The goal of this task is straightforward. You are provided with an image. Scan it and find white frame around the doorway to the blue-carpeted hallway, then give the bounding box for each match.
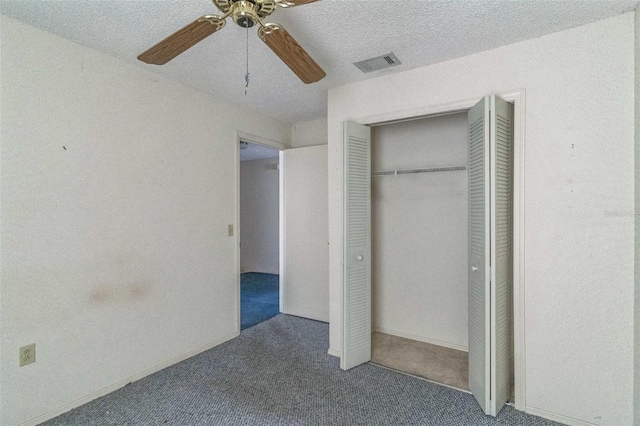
[234,130,291,335]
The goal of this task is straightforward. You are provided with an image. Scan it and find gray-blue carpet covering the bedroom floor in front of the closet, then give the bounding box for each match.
[45,315,555,426]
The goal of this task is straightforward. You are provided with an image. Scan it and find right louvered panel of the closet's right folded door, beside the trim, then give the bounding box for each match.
[489,96,513,416]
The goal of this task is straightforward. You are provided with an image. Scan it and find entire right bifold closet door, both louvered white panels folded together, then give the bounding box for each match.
[469,96,513,416]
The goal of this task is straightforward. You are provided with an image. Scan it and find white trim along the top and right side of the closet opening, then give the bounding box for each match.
[341,89,526,411]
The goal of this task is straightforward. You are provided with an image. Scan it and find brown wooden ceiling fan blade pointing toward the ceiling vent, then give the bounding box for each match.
[258,24,327,84]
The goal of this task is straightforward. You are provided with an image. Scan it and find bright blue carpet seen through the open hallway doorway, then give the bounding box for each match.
[240,272,280,330]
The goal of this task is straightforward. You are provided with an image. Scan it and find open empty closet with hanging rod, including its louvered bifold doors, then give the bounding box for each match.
[341,96,513,416]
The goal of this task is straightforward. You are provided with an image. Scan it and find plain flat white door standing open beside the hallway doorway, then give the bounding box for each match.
[282,144,329,322]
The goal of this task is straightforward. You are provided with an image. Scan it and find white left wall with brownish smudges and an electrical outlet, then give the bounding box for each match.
[0,16,291,426]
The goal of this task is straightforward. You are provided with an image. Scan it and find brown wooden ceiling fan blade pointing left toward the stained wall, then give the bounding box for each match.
[138,15,226,65]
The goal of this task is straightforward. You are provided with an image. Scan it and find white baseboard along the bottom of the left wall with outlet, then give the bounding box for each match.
[20,332,240,426]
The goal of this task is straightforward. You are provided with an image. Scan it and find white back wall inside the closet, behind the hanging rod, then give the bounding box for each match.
[371,113,469,351]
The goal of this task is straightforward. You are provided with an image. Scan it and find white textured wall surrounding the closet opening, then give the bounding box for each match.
[328,13,634,425]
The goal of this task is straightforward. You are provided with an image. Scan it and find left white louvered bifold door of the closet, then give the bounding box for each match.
[340,122,371,370]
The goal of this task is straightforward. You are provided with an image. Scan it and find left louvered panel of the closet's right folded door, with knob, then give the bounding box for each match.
[468,98,491,414]
